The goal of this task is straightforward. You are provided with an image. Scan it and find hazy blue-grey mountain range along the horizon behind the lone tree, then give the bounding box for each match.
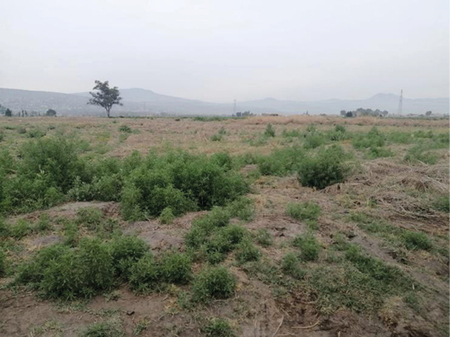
[0,88,449,116]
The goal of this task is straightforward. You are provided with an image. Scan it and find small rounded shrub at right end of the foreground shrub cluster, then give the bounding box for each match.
[192,267,236,302]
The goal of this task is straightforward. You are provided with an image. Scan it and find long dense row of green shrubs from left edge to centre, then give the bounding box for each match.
[0,137,248,219]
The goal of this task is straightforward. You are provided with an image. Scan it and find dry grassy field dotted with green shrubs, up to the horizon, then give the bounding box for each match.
[0,116,449,337]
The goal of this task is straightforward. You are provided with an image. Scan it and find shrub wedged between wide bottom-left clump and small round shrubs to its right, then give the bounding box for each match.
[110,235,149,278]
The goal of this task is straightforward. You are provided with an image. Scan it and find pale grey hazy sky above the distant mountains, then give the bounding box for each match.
[0,0,450,102]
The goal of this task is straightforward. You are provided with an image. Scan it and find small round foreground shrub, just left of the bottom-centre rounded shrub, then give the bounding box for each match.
[160,252,192,284]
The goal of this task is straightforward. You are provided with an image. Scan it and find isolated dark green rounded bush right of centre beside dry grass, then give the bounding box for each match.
[298,146,348,189]
